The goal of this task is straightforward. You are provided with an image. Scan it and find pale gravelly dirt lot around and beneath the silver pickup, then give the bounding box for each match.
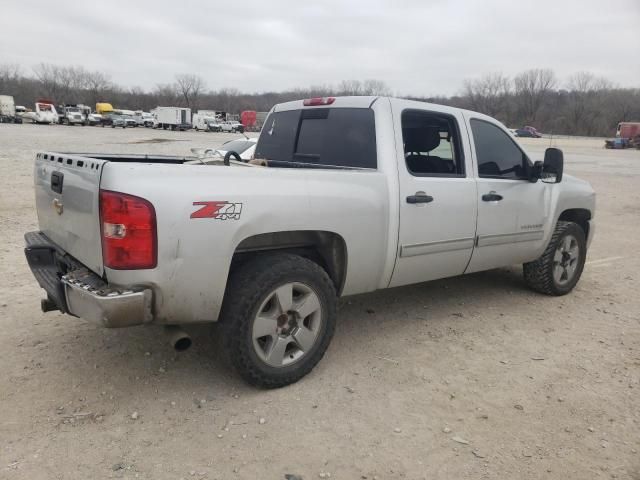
[0,125,640,480]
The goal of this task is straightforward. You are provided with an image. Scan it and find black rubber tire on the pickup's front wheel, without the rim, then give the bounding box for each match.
[522,221,587,296]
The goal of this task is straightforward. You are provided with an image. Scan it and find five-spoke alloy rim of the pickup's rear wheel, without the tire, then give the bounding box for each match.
[252,282,323,368]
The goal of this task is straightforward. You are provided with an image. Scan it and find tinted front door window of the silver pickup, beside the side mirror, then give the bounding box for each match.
[470,118,529,180]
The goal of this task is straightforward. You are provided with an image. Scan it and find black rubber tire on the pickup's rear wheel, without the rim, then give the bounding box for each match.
[220,254,337,388]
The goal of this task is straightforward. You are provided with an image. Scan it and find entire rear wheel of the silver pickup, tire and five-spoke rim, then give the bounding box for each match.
[221,254,337,388]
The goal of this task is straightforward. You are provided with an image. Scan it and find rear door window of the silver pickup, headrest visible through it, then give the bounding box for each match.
[402,110,464,177]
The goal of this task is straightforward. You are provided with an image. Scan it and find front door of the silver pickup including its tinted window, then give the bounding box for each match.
[466,116,551,272]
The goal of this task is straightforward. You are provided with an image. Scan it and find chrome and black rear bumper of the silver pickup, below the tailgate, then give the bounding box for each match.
[25,232,153,328]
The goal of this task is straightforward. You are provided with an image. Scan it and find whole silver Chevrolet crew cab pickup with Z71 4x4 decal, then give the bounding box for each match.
[25,97,595,387]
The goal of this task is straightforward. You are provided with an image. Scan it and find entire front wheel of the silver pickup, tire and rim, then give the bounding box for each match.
[522,221,587,296]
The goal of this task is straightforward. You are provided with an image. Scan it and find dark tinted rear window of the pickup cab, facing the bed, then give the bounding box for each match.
[255,108,377,169]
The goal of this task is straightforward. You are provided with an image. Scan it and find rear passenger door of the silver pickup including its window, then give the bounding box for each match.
[390,102,477,286]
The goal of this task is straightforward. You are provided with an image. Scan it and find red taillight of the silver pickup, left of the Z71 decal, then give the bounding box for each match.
[100,190,158,270]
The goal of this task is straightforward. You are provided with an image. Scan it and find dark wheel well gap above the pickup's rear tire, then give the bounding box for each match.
[231,230,347,295]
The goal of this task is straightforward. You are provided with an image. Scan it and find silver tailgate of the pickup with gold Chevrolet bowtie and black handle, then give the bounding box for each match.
[34,152,107,275]
